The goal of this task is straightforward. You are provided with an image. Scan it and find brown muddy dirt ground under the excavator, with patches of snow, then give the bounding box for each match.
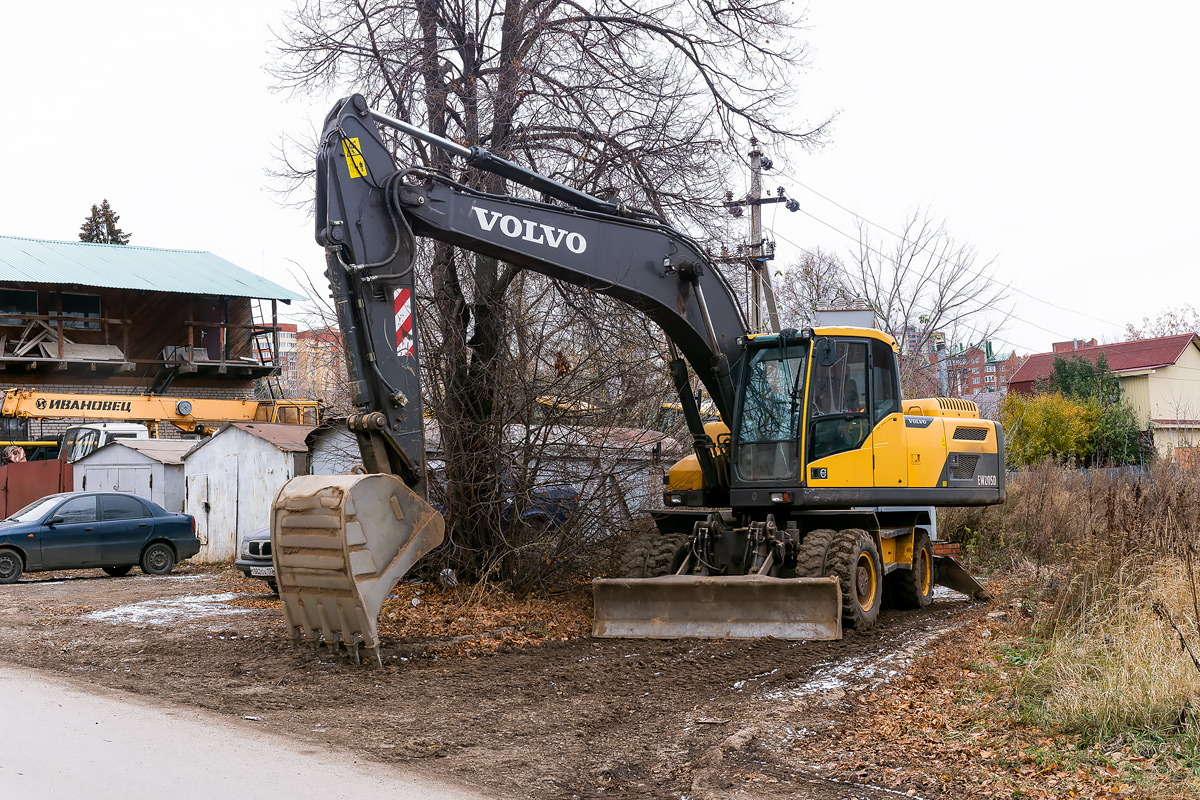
[0,565,996,800]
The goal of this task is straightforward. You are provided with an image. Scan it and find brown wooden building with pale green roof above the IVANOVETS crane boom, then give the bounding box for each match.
[0,236,305,438]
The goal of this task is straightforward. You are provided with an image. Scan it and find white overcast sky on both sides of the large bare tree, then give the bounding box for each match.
[0,0,1200,353]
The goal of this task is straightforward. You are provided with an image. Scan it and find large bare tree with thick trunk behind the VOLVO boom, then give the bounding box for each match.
[274,0,824,587]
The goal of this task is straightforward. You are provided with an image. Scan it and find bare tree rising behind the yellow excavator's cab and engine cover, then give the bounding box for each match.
[846,210,1012,392]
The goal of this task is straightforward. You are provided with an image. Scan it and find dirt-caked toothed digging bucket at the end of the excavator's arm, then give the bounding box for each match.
[271,475,445,657]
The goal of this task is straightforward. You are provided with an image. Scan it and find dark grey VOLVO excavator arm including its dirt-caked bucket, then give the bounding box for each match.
[271,95,746,657]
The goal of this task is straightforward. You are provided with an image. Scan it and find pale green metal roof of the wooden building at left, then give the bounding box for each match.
[0,236,307,301]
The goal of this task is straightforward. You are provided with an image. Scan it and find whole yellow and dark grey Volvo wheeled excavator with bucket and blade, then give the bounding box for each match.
[271,95,1004,660]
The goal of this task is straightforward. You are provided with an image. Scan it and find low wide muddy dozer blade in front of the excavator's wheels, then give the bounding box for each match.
[592,575,841,639]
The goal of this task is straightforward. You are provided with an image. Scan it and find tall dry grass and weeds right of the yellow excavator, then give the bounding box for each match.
[938,463,1200,792]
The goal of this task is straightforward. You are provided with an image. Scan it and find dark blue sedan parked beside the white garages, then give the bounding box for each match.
[0,492,200,583]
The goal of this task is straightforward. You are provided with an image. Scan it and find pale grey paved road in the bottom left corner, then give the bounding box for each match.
[0,667,484,800]
